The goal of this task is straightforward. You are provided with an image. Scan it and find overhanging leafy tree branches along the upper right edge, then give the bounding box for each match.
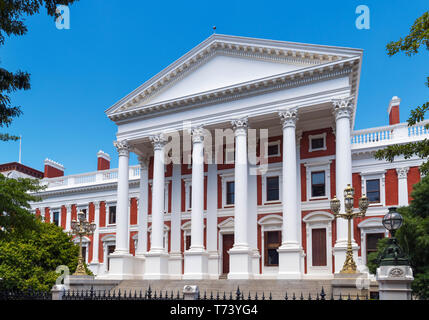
[375,12,429,174]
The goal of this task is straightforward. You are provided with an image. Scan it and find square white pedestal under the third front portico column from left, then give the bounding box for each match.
[182,249,209,280]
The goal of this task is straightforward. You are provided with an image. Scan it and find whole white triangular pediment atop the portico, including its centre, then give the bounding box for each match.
[106,35,361,118]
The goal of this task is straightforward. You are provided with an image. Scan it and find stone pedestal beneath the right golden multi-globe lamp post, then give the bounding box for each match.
[332,273,370,300]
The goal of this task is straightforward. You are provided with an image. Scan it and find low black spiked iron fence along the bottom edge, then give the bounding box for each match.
[62,287,369,300]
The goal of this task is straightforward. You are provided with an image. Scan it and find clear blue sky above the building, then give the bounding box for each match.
[0,0,429,174]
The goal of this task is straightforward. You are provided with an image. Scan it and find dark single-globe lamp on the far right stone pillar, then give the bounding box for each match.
[379,207,410,266]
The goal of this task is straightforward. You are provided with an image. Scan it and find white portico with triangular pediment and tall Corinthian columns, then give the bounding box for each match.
[106,35,362,280]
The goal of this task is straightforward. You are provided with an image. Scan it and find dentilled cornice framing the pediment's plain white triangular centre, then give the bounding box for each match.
[106,35,362,121]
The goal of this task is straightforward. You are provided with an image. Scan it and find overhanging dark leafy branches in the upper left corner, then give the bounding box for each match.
[0,0,77,141]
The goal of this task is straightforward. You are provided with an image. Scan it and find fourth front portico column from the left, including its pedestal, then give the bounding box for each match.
[228,118,253,279]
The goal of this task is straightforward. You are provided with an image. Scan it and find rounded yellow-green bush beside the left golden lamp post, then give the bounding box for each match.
[0,219,79,291]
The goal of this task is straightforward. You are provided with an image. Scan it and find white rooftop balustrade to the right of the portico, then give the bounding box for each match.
[351,120,429,149]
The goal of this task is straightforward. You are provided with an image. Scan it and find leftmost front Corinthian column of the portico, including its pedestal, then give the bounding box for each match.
[108,140,134,280]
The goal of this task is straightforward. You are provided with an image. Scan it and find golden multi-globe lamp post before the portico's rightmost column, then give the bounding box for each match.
[331,184,368,273]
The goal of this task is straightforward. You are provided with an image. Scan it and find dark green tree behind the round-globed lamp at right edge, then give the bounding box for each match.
[368,176,429,299]
